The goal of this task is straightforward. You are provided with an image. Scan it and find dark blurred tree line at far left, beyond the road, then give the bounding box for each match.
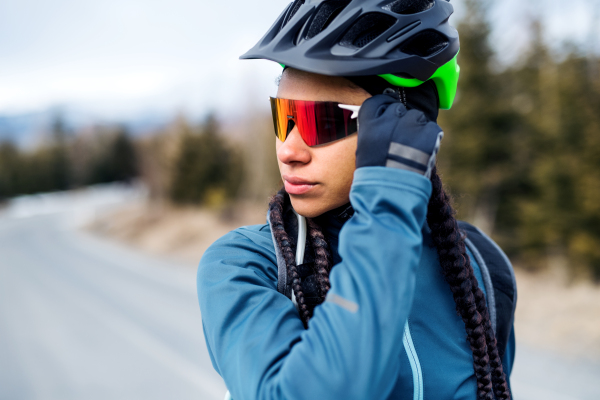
[0,117,138,201]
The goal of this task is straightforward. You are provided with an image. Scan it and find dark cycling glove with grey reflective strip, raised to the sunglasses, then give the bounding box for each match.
[356,94,444,178]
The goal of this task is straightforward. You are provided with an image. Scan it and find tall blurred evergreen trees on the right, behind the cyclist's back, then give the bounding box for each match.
[439,0,600,282]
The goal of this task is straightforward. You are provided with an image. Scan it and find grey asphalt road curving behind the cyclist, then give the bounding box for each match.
[0,186,600,400]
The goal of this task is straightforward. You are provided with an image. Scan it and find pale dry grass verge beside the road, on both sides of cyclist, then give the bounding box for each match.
[89,203,600,360]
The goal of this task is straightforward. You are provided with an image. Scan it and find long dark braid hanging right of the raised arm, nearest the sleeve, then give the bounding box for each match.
[427,168,493,399]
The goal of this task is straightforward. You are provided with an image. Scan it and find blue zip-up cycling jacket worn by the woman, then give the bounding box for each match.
[198,167,515,400]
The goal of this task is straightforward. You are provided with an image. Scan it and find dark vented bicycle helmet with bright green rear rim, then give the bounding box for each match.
[240,0,460,109]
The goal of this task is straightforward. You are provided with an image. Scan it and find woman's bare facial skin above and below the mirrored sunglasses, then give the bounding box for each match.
[275,68,370,218]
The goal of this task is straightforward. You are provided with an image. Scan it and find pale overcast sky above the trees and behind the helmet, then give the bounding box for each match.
[0,0,600,119]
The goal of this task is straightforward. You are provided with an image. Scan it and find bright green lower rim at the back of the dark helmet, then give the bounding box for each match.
[379,53,460,110]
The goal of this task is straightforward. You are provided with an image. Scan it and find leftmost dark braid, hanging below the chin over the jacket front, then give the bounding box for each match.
[269,189,310,327]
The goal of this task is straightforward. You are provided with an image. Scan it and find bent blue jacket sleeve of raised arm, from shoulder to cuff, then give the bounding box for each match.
[198,167,431,400]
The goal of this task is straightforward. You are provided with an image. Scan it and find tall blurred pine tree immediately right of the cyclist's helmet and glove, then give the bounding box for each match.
[440,0,519,234]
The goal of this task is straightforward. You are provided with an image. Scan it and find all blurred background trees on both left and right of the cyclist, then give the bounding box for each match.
[0,0,600,282]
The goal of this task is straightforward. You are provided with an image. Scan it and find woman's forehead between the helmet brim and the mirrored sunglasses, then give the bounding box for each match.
[277,68,370,104]
